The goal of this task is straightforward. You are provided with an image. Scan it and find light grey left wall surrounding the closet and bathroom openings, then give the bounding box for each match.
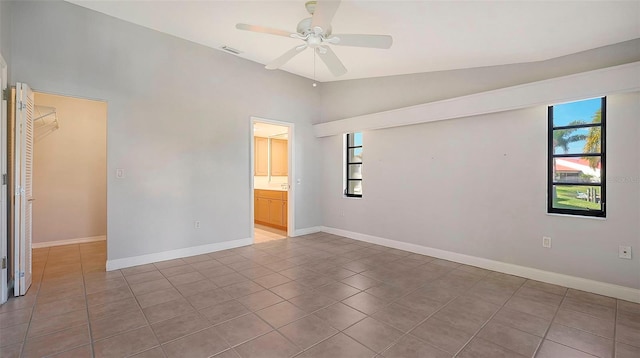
[11,1,322,260]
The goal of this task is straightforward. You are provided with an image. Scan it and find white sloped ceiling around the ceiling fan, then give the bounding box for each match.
[70,0,640,82]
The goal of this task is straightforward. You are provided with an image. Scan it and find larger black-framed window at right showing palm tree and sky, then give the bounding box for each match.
[547,97,607,217]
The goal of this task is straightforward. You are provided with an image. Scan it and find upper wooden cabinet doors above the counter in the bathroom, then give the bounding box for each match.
[253,137,289,176]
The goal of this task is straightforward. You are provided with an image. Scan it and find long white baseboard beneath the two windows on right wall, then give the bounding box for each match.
[322,226,640,303]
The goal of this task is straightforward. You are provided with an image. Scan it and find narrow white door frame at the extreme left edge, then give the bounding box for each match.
[0,54,6,304]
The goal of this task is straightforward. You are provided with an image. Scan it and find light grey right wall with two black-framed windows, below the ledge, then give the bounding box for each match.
[322,93,640,288]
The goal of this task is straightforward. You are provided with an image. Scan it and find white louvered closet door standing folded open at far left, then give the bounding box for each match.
[13,82,34,296]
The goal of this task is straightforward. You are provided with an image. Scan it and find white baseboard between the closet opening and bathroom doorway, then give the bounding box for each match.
[107,238,253,271]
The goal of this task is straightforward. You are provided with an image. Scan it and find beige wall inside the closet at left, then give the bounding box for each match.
[33,93,107,243]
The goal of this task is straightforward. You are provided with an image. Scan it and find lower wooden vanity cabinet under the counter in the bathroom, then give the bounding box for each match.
[254,189,288,230]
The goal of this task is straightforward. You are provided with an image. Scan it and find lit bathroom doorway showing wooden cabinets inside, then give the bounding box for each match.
[251,118,294,243]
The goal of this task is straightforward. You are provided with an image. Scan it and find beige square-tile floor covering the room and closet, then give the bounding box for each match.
[0,233,640,358]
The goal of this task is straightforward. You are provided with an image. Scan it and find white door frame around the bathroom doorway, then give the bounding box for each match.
[249,116,295,242]
